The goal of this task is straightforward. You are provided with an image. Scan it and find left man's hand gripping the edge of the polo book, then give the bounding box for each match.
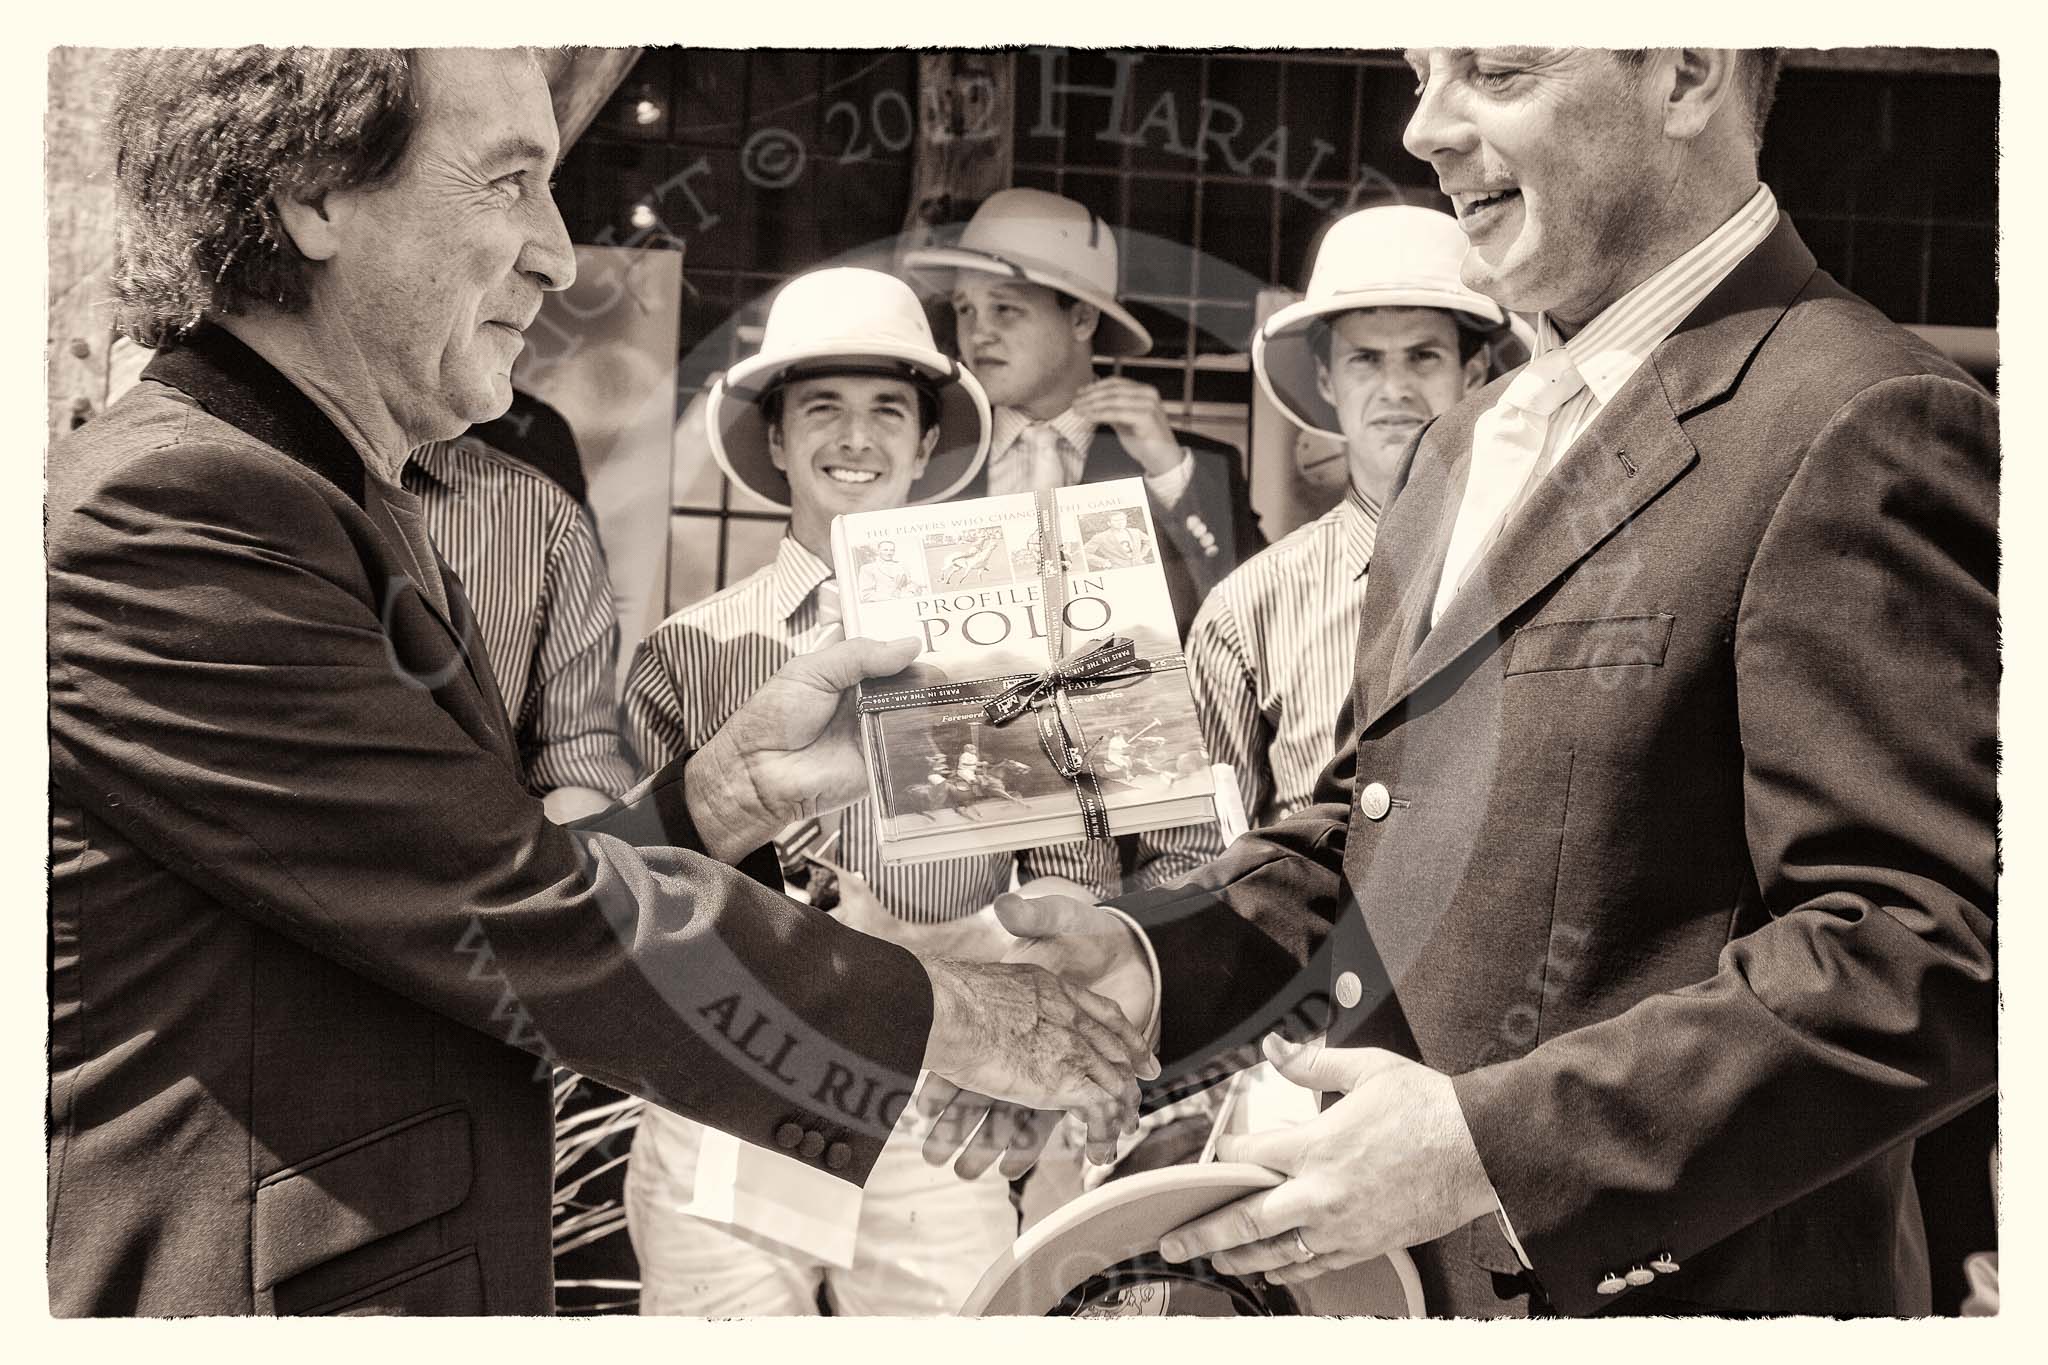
[686,639,918,862]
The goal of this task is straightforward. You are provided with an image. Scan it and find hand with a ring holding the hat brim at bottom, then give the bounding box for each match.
[1159,1036,1497,1285]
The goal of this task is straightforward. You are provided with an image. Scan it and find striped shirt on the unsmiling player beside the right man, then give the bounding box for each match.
[1139,487,1380,880]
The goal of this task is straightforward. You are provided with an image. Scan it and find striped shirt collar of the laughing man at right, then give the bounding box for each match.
[1536,184,1778,405]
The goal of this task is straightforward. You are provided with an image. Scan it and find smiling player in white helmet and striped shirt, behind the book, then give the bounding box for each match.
[625,268,1138,1316]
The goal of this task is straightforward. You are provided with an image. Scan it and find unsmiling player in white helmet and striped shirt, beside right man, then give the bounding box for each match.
[1145,205,1509,888]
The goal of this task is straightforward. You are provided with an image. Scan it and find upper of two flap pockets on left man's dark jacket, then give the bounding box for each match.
[250,1105,471,1293]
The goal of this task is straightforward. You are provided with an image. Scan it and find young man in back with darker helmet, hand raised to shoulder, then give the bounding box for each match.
[903,188,1266,632]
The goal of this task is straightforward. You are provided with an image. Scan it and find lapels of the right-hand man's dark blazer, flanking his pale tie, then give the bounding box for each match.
[1366,215,1815,726]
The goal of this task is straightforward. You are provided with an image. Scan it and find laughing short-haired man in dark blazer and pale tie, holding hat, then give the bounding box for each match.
[971,49,1999,1316]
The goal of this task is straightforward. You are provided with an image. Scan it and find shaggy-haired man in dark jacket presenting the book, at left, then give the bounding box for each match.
[47,49,1153,1316]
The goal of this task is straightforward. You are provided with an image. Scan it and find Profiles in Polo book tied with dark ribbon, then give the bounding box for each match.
[831,479,1214,862]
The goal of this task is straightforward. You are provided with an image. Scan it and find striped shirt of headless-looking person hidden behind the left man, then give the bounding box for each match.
[401,436,633,796]
